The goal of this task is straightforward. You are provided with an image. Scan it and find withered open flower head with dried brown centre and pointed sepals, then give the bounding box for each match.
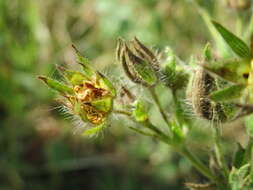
[39,45,116,130]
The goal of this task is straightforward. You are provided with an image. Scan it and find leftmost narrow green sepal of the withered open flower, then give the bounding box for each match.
[38,76,74,94]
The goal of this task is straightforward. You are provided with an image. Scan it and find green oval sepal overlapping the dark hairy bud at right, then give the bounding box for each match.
[209,84,245,102]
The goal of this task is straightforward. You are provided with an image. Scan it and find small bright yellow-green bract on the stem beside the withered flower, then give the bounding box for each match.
[132,100,148,122]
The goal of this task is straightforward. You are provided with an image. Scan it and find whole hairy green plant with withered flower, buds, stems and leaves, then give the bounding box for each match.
[39,21,253,190]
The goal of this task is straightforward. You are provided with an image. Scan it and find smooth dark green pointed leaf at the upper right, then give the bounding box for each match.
[212,21,251,58]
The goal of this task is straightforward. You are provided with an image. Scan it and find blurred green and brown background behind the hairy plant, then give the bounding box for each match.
[0,0,251,190]
